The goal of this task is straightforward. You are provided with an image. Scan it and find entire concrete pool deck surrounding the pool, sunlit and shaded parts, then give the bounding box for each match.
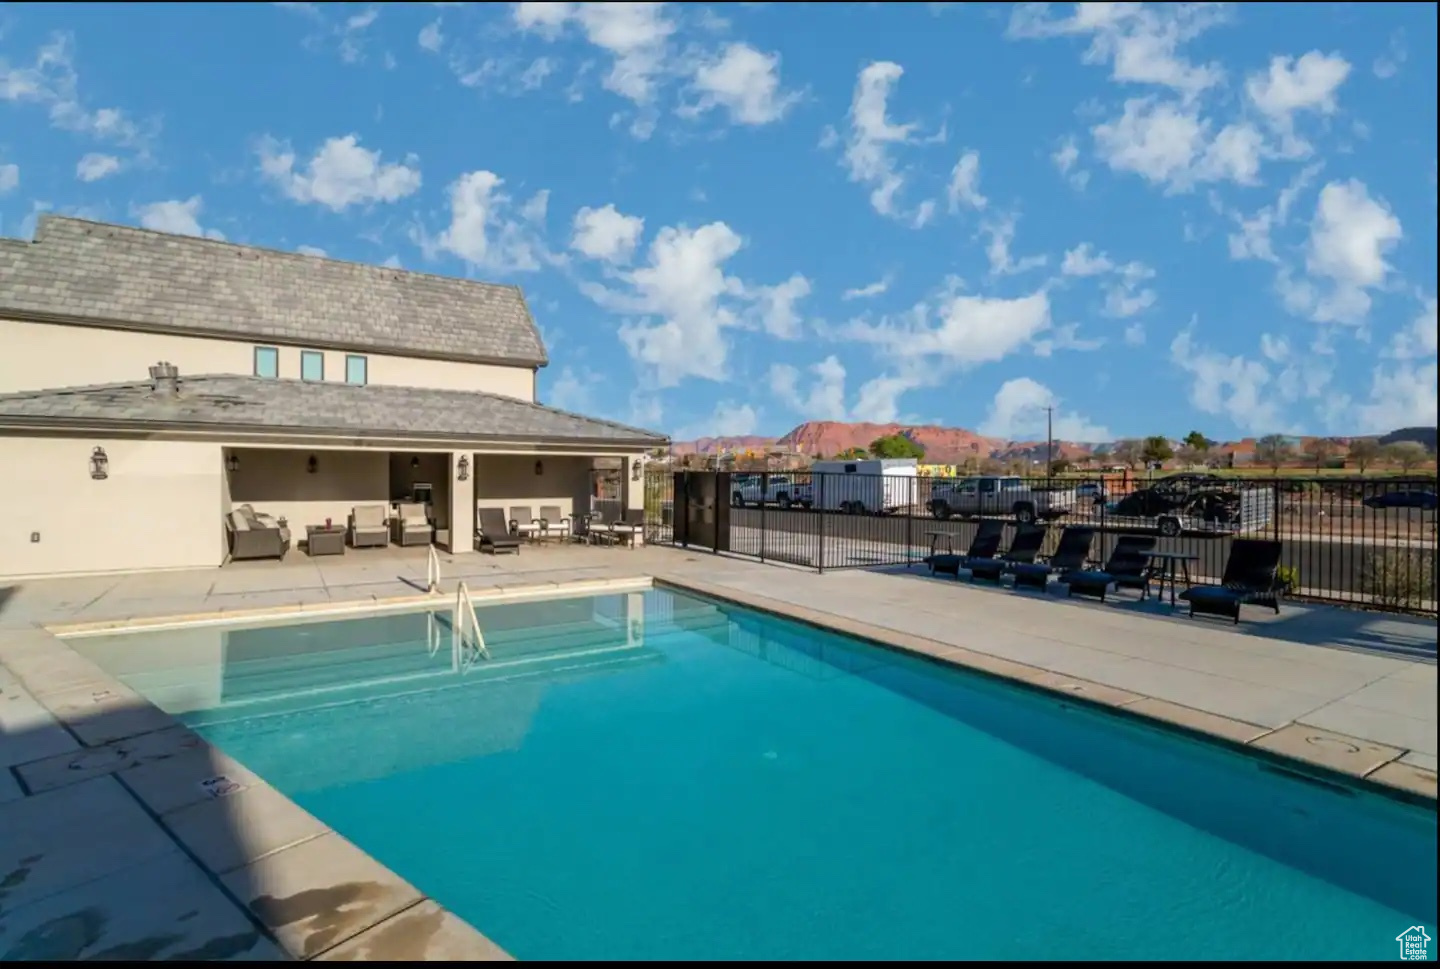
[0,547,1437,960]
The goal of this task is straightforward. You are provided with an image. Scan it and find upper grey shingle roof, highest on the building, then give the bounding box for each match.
[0,215,547,366]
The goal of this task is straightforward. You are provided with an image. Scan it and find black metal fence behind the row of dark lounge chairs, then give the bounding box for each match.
[645,471,1437,615]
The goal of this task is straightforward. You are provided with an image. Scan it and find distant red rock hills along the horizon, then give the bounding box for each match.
[672,420,1436,464]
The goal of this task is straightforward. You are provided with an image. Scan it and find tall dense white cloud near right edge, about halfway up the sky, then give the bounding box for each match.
[1282,179,1403,323]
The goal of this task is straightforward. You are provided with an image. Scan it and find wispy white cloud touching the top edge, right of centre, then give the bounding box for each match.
[1009,3,1227,98]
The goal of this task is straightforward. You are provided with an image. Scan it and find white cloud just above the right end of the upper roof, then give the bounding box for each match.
[415,170,552,274]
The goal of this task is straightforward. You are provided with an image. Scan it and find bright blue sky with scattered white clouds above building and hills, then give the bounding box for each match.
[0,3,1437,441]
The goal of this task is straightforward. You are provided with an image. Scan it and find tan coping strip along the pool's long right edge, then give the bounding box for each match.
[652,573,1437,811]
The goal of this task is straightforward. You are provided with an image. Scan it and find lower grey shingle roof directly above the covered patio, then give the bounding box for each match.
[0,376,665,448]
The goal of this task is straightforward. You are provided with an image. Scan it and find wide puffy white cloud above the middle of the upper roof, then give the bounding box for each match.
[259,134,420,212]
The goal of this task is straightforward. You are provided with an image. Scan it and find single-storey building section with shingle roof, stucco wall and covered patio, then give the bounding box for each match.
[0,362,665,577]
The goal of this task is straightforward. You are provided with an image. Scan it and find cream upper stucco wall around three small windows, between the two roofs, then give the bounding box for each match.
[0,320,536,402]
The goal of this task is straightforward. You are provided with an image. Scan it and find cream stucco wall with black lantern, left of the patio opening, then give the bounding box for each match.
[0,435,225,577]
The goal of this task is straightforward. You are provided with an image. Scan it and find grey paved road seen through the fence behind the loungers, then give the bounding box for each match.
[714,508,1436,598]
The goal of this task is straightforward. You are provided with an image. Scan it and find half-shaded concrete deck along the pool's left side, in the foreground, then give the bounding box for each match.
[0,631,508,962]
